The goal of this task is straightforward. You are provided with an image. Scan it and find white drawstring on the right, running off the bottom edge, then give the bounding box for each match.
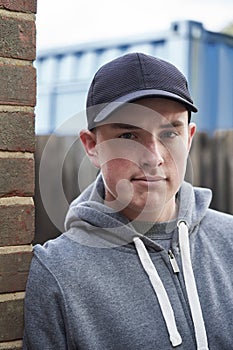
[178,221,209,350]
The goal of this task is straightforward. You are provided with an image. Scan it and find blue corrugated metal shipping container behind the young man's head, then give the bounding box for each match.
[36,21,233,134]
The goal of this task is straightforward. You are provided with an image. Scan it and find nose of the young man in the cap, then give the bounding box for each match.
[140,137,164,169]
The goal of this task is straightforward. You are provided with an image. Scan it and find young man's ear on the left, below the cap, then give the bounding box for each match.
[80,130,100,168]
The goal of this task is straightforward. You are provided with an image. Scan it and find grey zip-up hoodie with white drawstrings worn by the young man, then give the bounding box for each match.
[23,176,233,350]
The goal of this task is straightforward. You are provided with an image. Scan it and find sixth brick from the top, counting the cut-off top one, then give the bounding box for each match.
[0,197,35,246]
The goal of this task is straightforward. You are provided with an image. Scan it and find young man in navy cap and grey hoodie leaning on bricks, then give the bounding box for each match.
[24,53,233,350]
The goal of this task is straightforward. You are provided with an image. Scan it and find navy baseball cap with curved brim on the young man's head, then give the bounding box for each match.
[86,53,198,130]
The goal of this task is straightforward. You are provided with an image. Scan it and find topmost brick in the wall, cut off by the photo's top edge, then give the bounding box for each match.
[0,0,37,13]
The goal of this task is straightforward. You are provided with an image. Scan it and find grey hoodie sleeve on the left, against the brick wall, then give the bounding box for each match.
[23,256,68,350]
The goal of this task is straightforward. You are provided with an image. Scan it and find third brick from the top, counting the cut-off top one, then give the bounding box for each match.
[0,64,36,107]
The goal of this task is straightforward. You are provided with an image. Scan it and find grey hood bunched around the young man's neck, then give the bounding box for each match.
[65,174,212,246]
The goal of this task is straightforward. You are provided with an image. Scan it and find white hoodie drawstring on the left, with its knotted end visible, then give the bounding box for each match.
[133,237,182,347]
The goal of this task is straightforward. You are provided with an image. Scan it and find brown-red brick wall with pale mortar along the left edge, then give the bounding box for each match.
[0,0,36,350]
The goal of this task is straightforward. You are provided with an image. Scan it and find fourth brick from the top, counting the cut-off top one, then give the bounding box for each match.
[0,112,35,152]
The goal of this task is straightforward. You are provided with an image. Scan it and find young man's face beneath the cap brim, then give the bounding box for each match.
[81,98,195,221]
